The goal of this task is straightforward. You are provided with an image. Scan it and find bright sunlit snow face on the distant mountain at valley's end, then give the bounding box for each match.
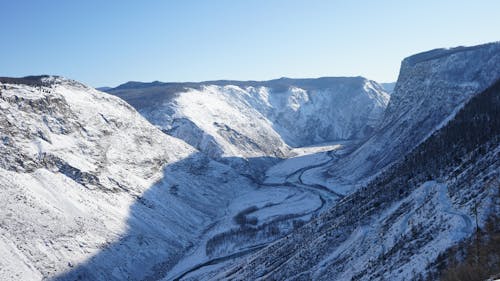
[176,86,288,157]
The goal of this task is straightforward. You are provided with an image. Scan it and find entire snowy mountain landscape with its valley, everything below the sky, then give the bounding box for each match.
[0,42,500,280]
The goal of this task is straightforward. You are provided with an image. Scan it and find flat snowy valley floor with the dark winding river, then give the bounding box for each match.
[164,141,351,280]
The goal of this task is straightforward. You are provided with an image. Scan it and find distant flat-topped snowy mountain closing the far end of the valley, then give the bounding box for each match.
[108,77,389,161]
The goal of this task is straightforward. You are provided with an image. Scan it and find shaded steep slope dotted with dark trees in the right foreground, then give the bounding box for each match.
[218,70,500,280]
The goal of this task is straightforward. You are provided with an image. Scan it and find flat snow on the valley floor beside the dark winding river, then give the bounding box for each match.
[164,142,349,280]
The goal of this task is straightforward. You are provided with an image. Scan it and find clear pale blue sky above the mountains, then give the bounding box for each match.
[0,0,500,87]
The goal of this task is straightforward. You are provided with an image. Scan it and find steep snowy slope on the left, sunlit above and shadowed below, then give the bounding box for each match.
[0,76,253,280]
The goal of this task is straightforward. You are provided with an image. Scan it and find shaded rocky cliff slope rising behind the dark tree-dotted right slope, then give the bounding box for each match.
[330,43,500,182]
